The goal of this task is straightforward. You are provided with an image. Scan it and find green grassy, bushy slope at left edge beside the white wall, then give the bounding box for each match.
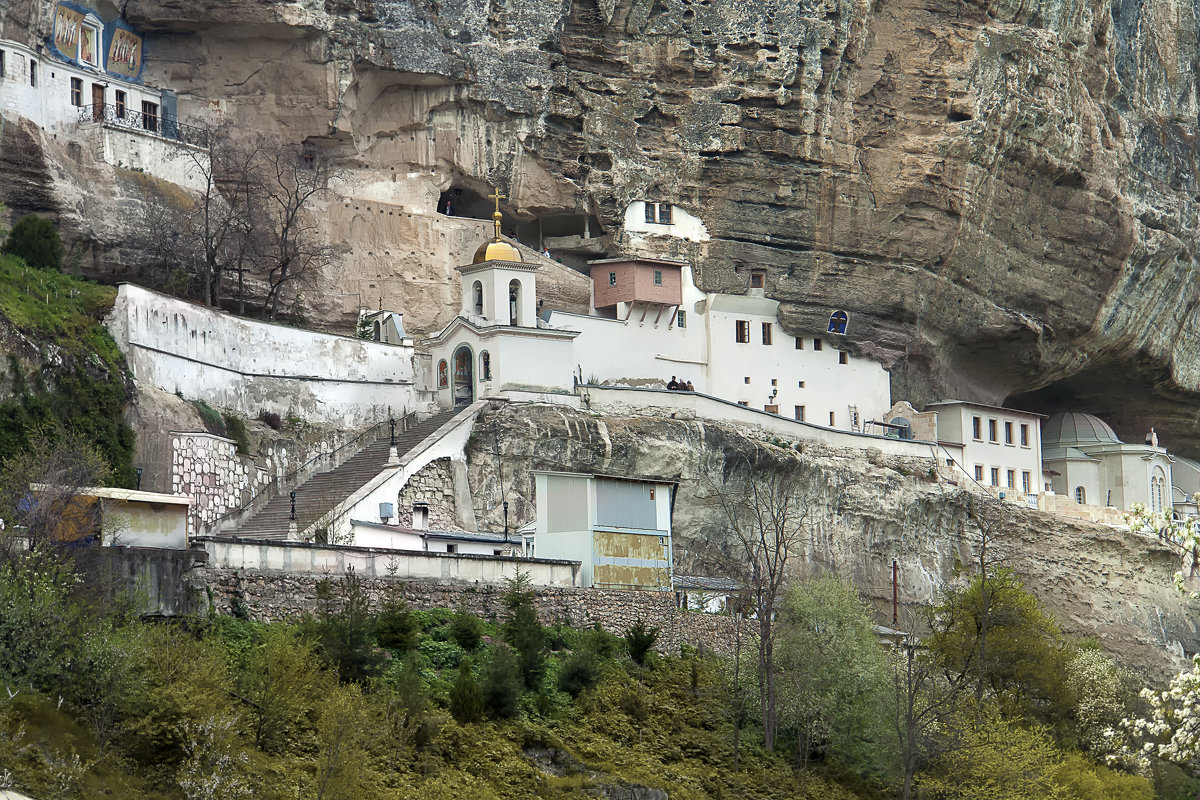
[0,254,136,487]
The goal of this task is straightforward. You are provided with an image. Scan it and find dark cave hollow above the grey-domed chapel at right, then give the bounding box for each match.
[1004,360,1200,458]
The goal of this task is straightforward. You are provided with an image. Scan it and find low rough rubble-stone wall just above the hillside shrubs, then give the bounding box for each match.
[205,569,749,654]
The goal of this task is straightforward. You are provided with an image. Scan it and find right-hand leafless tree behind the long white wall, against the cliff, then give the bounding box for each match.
[263,145,335,319]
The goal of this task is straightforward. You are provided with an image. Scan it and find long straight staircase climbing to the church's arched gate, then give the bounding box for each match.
[234,409,462,540]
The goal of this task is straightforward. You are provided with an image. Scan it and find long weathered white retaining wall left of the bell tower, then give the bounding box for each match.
[108,284,422,426]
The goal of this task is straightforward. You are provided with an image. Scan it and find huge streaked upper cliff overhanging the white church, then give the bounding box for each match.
[0,0,1200,450]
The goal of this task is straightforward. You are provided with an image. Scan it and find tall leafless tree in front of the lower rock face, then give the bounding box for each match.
[697,447,812,750]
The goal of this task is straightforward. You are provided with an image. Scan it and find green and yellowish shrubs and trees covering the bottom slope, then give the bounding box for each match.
[0,548,1161,800]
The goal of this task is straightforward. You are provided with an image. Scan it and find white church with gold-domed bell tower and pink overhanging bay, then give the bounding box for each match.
[425,203,890,431]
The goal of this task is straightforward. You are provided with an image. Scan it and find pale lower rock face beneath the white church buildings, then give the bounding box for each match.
[467,405,1200,678]
